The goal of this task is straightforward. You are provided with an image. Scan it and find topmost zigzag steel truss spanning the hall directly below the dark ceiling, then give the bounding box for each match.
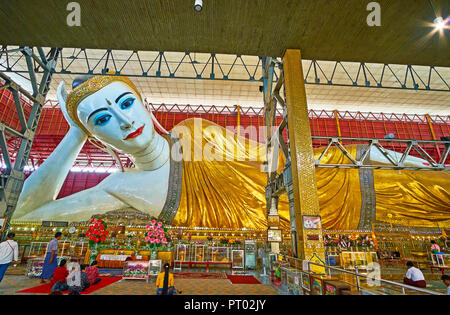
[0,46,450,92]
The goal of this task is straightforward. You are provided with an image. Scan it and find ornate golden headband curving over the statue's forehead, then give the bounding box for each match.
[66,75,142,136]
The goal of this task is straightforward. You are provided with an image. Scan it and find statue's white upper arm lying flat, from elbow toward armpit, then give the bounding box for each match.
[20,185,129,221]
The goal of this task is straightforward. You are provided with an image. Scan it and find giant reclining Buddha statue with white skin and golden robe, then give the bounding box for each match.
[13,75,450,229]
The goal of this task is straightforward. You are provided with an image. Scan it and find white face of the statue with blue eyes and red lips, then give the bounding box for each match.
[77,82,154,154]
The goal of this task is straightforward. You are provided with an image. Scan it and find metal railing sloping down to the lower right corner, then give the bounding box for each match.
[282,255,443,295]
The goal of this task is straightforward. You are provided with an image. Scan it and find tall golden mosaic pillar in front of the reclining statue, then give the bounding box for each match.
[283,49,325,269]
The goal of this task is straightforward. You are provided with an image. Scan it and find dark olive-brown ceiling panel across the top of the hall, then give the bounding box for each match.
[0,0,450,67]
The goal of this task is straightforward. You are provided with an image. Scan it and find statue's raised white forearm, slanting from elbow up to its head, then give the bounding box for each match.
[14,128,87,217]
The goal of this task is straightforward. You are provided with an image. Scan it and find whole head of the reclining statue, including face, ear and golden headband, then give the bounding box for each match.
[58,76,155,154]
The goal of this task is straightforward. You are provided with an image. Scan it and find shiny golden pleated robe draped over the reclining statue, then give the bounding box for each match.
[172,119,450,230]
